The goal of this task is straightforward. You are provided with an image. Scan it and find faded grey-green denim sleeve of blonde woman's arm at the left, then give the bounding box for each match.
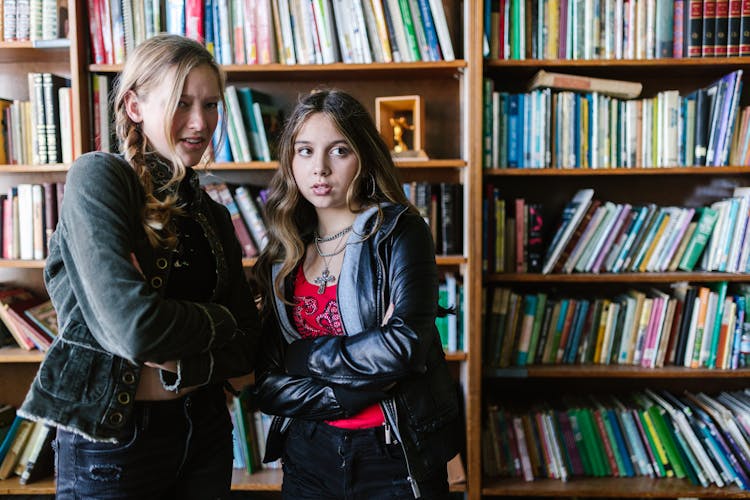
[51,153,237,362]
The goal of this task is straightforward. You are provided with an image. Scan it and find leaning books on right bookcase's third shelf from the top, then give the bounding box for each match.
[542,188,750,274]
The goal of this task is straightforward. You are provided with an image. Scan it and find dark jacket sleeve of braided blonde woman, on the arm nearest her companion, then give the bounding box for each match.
[162,207,260,389]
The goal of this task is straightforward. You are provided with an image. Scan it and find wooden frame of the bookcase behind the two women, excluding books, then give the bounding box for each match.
[0,0,482,498]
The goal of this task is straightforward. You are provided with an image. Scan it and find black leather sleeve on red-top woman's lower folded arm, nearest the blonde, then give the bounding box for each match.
[253,314,387,420]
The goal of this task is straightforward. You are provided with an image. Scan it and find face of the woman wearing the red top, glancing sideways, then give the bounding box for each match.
[292,113,359,212]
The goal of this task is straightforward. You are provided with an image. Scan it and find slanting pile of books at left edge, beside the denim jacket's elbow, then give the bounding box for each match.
[0,285,58,352]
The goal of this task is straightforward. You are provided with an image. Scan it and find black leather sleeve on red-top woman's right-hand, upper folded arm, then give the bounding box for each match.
[285,213,439,390]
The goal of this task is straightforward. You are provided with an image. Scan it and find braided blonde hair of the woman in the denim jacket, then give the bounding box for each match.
[114,34,225,248]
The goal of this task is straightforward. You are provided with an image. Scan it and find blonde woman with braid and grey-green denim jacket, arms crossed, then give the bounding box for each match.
[20,35,259,500]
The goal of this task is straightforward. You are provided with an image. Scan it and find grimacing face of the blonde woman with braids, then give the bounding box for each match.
[128,65,221,167]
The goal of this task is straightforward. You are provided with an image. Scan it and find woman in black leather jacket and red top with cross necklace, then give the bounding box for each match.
[255,90,462,500]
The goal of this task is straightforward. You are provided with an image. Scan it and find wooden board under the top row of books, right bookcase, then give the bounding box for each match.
[484,57,750,71]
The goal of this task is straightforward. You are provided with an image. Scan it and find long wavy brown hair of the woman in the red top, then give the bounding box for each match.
[253,89,416,301]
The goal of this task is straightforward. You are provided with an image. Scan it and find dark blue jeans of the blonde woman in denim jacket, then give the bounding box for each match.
[55,386,232,500]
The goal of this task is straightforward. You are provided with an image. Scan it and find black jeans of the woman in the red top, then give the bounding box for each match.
[281,420,448,500]
